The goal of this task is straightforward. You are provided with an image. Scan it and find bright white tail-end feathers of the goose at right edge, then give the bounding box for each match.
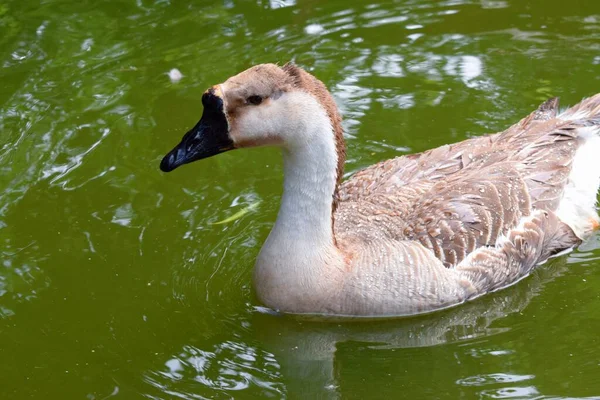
[556,127,600,239]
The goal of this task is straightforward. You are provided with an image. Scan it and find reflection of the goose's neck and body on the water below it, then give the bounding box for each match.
[252,258,567,399]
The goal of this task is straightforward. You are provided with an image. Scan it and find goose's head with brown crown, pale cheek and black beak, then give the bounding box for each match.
[160,64,345,176]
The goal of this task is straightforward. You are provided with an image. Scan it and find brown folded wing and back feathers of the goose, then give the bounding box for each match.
[334,99,579,267]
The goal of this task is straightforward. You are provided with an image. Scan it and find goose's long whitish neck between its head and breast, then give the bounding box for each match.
[267,93,339,252]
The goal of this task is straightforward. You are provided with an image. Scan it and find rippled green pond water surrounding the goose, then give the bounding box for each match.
[0,0,600,399]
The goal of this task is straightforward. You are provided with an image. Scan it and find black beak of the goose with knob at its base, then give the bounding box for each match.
[160,89,234,172]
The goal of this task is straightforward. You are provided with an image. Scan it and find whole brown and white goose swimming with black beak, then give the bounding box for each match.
[160,64,600,316]
